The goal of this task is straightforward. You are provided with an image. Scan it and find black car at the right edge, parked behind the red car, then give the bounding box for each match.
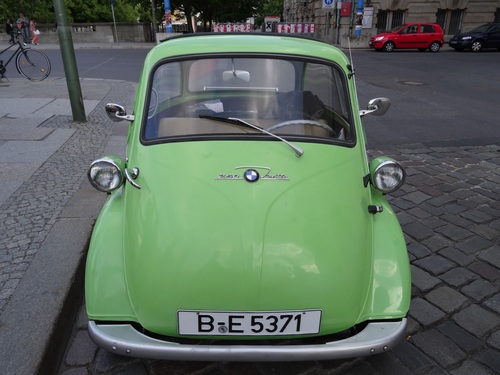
[449,23,500,52]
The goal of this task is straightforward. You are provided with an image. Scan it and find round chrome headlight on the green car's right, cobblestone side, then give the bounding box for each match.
[370,158,406,194]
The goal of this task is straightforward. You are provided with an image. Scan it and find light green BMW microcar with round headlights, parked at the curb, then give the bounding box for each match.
[85,33,411,361]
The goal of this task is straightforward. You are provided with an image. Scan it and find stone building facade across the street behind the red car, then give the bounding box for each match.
[283,0,500,45]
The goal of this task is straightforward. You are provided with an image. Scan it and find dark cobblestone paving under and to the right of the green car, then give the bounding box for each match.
[60,144,500,375]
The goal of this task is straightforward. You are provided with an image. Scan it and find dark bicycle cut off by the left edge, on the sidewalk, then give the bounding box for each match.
[0,32,51,81]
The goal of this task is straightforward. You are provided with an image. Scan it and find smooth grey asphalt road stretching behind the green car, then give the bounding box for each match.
[42,48,500,147]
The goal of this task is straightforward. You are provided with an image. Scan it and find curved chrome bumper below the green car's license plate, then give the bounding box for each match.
[88,319,407,362]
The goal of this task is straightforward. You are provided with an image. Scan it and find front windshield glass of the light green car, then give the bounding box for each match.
[142,56,353,143]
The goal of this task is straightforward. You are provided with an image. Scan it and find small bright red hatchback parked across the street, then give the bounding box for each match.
[368,22,444,52]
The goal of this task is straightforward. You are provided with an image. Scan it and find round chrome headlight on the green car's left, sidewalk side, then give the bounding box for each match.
[87,156,125,193]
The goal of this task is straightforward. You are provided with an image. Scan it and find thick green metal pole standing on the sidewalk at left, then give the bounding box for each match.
[54,0,87,122]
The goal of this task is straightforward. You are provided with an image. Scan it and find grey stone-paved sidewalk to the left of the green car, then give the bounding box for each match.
[0,77,136,375]
